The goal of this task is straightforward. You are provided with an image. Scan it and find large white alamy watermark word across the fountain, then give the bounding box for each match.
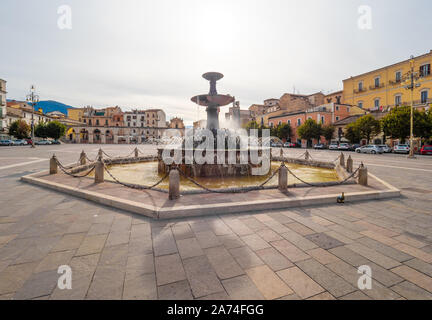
[162,129,270,176]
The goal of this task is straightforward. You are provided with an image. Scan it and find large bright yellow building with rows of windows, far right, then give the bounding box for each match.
[343,50,432,111]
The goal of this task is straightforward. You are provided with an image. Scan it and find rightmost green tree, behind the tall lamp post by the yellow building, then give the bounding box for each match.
[381,106,432,143]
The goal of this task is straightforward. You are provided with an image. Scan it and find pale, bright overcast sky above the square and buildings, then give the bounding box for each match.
[0,0,432,125]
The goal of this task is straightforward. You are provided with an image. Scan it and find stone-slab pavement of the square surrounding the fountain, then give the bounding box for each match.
[0,145,432,299]
